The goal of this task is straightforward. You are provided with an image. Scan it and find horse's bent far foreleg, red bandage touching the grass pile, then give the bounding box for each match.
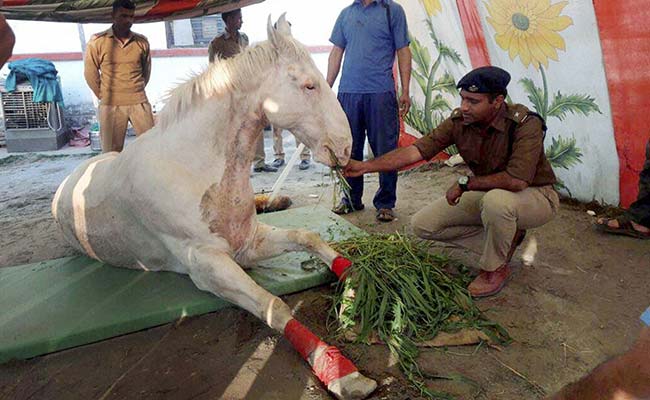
[239,223,352,279]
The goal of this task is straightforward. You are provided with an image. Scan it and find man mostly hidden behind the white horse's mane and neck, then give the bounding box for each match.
[208,9,278,172]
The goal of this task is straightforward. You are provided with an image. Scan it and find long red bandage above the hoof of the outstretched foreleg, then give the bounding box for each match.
[284,319,357,386]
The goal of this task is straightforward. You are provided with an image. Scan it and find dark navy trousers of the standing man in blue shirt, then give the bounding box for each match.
[338,92,399,209]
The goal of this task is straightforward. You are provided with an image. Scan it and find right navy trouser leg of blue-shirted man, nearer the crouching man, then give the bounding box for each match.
[364,92,399,214]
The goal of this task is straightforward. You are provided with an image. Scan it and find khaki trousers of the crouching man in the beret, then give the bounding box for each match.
[411,185,560,271]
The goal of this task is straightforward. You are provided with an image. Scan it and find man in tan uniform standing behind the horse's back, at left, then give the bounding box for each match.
[84,0,153,153]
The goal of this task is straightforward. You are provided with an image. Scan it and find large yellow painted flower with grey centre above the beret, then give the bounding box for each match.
[484,0,573,68]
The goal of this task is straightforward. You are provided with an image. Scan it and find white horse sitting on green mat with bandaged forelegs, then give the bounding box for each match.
[52,15,376,399]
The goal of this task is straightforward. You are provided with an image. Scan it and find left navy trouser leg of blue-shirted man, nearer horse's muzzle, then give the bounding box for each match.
[338,93,367,209]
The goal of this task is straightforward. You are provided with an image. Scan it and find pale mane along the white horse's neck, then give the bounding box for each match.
[157,33,311,129]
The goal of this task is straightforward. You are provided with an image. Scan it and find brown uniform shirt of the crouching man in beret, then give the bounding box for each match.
[414,103,556,186]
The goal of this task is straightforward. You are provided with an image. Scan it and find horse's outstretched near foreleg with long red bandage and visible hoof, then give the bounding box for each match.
[185,247,377,399]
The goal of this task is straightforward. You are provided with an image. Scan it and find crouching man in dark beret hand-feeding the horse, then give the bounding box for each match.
[345,67,559,297]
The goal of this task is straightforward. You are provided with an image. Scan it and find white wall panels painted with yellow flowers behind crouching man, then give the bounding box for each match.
[400,0,619,204]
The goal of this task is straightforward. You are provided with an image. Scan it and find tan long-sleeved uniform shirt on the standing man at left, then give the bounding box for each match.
[84,28,151,106]
